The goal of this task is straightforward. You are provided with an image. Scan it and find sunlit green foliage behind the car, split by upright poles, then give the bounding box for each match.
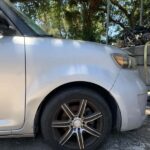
[12,0,150,42]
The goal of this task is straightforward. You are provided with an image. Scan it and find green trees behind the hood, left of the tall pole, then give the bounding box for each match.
[13,0,105,42]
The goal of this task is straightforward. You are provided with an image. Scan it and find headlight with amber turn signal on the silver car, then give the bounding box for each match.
[112,53,136,69]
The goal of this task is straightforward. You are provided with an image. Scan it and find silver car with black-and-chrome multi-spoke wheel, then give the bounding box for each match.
[0,0,147,150]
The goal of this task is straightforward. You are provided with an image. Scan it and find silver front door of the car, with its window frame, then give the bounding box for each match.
[0,10,25,134]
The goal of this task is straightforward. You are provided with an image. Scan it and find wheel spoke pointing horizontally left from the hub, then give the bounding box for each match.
[52,121,71,128]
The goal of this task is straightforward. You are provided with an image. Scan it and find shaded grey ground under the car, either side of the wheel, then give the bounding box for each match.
[0,108,150,150]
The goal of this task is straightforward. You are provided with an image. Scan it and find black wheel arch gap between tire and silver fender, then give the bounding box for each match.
[34,81,122,134]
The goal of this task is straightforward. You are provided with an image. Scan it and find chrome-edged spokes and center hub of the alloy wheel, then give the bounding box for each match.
[52,100,103,150]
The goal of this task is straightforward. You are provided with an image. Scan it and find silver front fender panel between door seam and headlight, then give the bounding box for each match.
[13,37,120,134]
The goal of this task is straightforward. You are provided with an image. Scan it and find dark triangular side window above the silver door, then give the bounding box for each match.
[0,10,19,36]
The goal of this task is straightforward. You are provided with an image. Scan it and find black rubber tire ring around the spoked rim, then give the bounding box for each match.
[41,88,112,150]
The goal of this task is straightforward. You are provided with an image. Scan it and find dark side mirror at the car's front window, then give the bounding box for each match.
[0,17,16,36]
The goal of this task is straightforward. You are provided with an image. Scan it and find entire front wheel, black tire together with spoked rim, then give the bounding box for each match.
[41,88,112,150]
